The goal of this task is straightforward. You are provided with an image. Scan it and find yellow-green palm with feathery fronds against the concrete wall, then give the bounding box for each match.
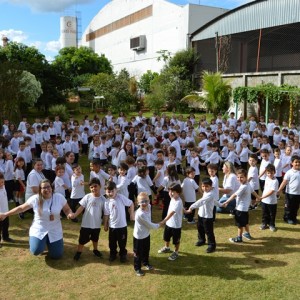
[202,72,231,116]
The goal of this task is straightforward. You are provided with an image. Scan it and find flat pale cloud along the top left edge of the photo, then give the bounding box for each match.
[2,0,95,12]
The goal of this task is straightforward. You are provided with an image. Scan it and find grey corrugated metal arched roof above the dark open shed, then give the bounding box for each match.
[192,0,300,41]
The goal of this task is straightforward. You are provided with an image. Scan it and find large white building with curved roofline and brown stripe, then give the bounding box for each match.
[82,0,227,77]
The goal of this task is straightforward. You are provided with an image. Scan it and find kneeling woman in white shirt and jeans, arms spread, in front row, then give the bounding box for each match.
[0,179,72,259]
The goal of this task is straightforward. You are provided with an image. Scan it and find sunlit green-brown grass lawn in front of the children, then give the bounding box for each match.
[0,152,300,300]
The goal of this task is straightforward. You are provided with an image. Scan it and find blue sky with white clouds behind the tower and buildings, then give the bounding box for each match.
[0,0,250,60]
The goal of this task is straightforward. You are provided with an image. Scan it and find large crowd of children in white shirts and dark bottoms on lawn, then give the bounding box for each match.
[0,112,300,276]
